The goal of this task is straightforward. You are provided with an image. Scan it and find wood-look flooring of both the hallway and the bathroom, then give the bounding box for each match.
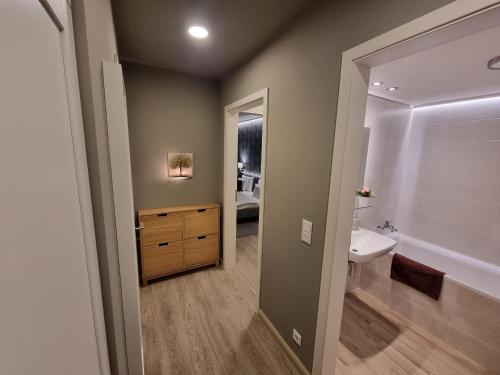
[141,235,487,375]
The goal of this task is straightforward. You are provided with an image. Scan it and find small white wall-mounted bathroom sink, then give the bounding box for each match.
[349,228,396,263]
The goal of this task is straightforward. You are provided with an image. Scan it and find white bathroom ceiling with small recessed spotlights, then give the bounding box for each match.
[369,21,500,106]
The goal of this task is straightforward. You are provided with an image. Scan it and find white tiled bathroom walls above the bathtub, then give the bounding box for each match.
[358,96,500,266]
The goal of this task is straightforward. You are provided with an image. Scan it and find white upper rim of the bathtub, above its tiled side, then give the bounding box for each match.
[389,233,500,301]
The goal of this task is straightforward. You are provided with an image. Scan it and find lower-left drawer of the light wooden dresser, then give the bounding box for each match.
[142,241,184,277]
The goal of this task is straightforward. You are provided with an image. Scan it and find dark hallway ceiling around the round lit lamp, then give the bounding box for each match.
[113,0,315,78]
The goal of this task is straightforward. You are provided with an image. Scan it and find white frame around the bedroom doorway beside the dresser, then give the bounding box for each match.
[222,87,269,307]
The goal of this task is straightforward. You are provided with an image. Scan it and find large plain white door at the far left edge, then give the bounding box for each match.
[0,0,106,375]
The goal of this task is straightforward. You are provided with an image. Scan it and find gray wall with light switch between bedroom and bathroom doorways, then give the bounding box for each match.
[223,0,450,369]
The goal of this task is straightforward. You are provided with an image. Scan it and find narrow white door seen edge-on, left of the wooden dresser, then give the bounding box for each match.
[102,61,144,375]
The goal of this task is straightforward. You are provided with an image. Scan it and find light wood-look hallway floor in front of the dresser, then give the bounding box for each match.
[141,235,299,375]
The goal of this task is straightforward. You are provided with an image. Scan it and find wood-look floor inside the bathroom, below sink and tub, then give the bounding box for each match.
[336,290,490,375]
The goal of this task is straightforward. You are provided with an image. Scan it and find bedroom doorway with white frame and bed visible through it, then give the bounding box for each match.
[223,88,268,306]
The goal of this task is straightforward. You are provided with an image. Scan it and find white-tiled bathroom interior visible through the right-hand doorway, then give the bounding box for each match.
[337,13,500,374]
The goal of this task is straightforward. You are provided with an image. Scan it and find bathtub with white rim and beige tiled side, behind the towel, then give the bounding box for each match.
[358,233,500,375]
